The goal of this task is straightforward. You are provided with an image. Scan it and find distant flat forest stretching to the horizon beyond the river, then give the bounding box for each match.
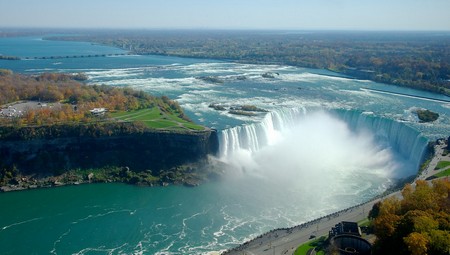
[48,30,450,95]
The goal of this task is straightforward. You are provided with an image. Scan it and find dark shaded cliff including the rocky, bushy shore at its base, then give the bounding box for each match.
[0,126,221,191]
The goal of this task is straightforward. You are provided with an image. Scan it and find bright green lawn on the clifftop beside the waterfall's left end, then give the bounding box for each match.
[111,107,205,130]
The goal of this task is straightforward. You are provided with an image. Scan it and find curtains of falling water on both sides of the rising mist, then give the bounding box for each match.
[219,108,428,170]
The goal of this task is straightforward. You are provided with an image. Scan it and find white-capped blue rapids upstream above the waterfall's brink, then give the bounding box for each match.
[78,59,450,137]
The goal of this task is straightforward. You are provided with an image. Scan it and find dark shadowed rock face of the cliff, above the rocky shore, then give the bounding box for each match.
[0,131,218,174]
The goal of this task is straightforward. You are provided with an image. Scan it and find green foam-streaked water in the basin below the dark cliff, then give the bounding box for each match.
[0,180,314,254]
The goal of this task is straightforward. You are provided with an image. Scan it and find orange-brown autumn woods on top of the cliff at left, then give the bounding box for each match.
[0,69,189,127]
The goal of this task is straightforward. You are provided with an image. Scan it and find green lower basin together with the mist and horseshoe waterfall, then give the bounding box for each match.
[0,108,427,255]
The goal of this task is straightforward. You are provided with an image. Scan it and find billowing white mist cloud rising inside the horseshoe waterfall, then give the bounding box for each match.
[216,111,403,215]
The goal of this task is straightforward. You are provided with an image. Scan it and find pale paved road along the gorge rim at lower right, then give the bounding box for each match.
[223,144,450,255]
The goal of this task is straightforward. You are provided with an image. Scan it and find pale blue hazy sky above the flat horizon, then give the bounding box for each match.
[0,0,450,30]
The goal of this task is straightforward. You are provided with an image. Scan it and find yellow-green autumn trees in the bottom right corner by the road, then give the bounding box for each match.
[369,179,450,255]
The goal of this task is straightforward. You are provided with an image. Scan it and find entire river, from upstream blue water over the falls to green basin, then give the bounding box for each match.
[0,37,450,254]
